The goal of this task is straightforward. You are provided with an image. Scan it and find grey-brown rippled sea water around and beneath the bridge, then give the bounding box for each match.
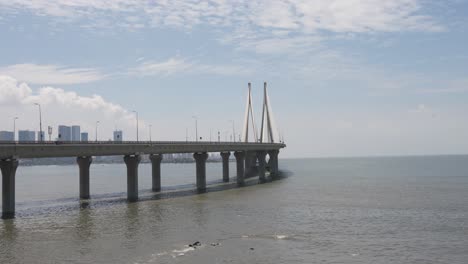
[0,155,468,263]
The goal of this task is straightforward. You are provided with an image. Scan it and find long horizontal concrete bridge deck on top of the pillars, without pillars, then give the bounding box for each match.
[0,141,286,159]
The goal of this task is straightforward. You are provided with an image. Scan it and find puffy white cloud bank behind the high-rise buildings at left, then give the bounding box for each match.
[0,75,138,139]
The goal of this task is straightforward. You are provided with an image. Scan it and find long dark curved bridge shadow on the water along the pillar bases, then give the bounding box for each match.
[12,171,292,218]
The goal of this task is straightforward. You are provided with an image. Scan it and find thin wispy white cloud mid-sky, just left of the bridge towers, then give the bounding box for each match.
[128,57,252,76]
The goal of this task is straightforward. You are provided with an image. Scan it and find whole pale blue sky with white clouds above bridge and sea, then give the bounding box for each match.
[0,0,468,158]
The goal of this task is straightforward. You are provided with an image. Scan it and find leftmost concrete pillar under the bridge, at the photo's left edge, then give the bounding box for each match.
[0,159,18,219]
